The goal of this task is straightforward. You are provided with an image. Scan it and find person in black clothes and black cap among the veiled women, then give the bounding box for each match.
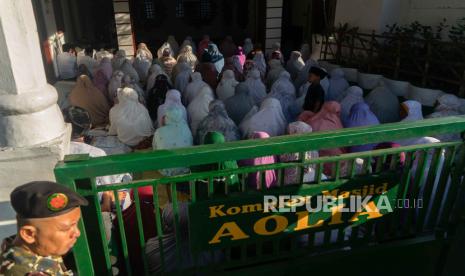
[303,66,327,113]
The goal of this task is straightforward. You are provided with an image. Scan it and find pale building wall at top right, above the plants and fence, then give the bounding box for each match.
[335,0,465,32]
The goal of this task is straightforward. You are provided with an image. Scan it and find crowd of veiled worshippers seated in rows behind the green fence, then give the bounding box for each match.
[57,35,465,270]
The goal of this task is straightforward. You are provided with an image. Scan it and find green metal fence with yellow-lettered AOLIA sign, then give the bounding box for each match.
[55,117,465,275]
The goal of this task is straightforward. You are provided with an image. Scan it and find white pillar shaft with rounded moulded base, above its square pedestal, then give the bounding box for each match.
[0,0,66,148]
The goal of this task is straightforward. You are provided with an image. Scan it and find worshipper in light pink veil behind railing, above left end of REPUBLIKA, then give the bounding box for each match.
[241,132,277,189]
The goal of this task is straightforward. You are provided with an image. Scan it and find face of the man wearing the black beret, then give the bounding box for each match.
[26,208,81,256]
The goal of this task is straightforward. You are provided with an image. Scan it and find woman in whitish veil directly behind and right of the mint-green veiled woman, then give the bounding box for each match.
[187,86,215,133]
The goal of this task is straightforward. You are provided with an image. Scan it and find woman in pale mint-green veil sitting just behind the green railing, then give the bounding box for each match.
[152,106,193,176]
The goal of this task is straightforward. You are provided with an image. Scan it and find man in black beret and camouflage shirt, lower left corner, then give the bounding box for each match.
[0,181,88,276]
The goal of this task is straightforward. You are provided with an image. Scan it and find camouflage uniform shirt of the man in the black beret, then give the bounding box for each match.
[0,236,73,276]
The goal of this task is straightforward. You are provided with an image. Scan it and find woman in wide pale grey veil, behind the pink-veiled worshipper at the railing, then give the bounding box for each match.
[239,97,287,137]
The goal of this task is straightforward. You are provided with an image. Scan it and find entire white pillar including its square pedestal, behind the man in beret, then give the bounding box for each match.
[0,0,70,238]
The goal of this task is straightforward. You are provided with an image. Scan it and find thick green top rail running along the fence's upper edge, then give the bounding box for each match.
[57,116,465,179]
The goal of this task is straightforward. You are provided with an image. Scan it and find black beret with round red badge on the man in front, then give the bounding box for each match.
[10,181,88,219]
